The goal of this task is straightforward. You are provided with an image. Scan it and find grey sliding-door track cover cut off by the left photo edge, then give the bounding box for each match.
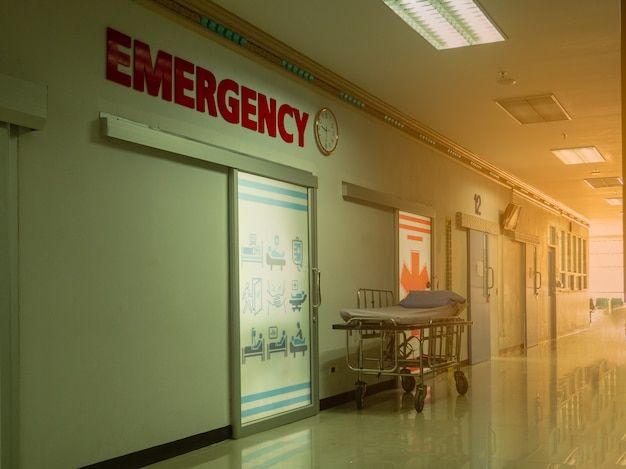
[0,73,48,130]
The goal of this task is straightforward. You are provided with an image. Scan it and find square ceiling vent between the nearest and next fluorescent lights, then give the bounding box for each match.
[496,94,571,124]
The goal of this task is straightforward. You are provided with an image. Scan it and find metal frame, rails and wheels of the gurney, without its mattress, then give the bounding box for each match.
[332,288,472,412]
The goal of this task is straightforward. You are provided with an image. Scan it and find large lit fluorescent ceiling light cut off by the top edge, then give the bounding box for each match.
[383,0,504,49]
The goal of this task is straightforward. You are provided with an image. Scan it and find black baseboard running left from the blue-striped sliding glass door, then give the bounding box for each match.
[82,425,233,469]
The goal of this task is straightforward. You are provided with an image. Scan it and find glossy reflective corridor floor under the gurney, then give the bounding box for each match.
[151,310,626,469]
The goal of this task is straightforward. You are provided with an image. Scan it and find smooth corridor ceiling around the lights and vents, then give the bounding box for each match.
[214,0,622,225]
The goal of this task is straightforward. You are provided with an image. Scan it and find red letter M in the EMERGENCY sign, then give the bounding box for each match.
[133,39,172,101]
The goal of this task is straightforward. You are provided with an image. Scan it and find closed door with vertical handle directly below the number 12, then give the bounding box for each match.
[468,230,494,364]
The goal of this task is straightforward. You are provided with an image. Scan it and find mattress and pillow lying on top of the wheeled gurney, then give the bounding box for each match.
[339,291,465,325]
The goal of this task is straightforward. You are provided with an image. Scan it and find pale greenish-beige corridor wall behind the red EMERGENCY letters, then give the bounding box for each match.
[0,0,580,468]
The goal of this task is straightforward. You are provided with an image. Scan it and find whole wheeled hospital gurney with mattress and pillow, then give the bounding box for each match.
[333,289,471,412]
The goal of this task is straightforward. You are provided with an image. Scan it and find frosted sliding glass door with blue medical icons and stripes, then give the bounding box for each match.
[231,171,319,436]
